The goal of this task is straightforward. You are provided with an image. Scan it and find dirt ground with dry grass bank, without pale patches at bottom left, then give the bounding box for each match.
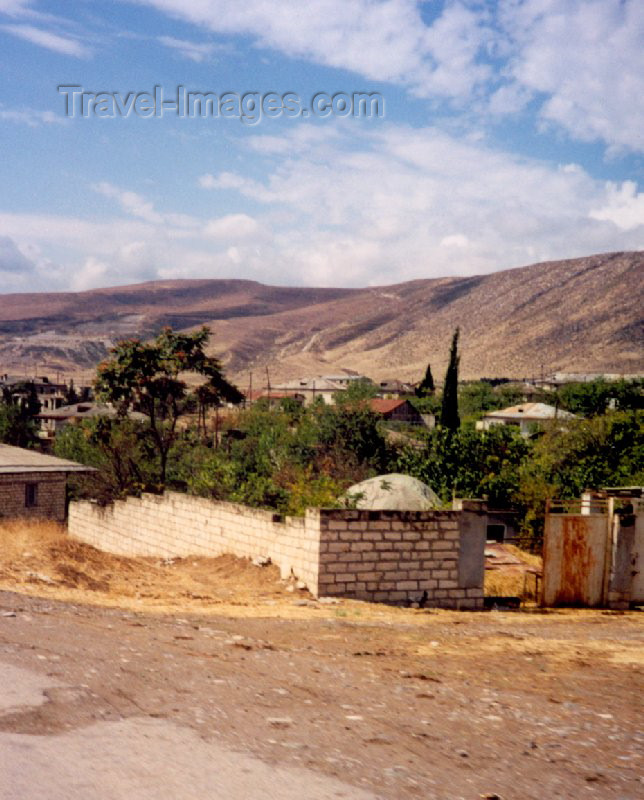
[0,524,644,800]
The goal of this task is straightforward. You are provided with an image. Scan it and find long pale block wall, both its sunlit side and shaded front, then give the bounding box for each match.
[69,492,487,608]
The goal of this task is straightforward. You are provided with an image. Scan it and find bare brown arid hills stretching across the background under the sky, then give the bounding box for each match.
[0,252,644,387]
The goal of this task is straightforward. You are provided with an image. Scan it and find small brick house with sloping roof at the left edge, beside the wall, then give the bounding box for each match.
[0,444,93,522]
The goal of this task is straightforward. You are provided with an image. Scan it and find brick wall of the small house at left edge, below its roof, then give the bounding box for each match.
[0,472,67,522]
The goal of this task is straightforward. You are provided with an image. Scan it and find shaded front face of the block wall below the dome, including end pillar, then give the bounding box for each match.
[318,507,487,609]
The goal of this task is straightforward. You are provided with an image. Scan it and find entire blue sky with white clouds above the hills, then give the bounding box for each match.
[0,0,644,292]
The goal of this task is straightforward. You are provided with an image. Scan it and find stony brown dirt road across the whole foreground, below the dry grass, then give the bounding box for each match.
[0,592,644,800]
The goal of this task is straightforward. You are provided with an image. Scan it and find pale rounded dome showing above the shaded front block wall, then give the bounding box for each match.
[344,472,441,511]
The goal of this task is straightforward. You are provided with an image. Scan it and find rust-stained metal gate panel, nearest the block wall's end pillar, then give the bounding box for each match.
[542,514,608,606]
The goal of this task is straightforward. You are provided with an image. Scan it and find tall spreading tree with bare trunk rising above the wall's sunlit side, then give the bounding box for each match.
[95,327,243,488]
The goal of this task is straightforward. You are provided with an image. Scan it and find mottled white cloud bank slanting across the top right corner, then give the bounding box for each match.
[131,0,644,151]
